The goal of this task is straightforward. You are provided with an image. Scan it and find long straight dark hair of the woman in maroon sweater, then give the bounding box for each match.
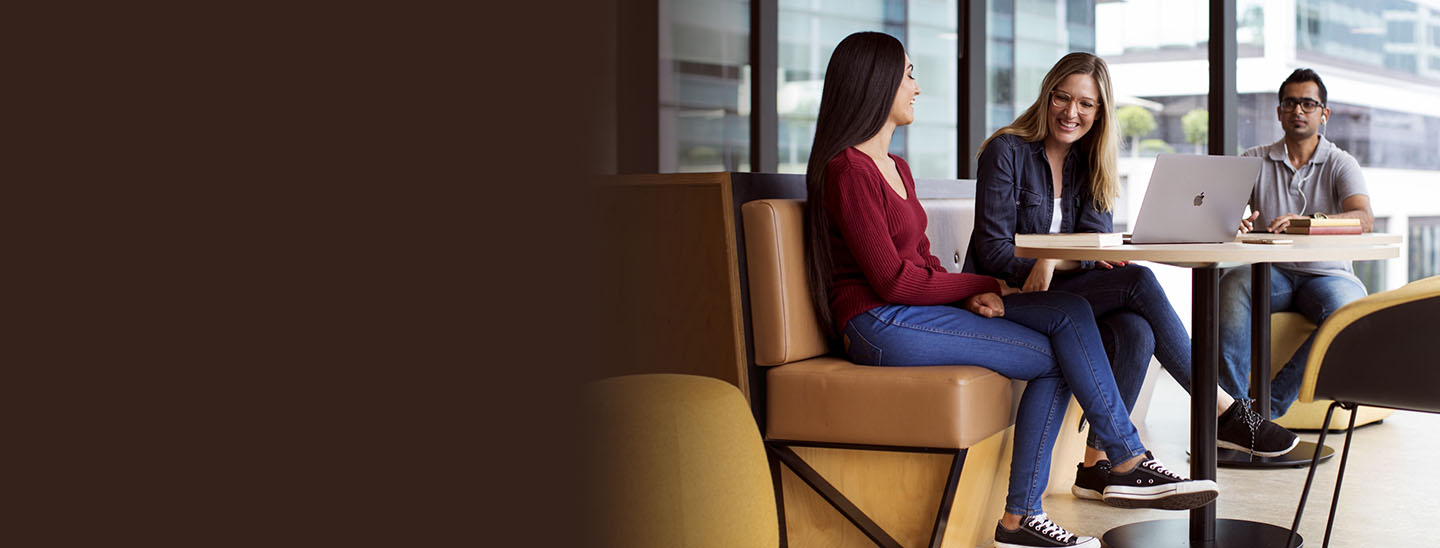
[805,32,904,339]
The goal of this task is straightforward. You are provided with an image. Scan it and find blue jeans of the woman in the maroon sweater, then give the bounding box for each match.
[845,292,1145,515]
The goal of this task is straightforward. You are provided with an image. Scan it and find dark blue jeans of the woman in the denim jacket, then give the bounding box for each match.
[1050,265,1191,448]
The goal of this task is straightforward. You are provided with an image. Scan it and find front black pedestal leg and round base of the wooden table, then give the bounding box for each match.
[1102,265,1305,548]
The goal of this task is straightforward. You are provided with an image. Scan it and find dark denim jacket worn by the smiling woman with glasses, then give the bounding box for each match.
[960,135,1115,288]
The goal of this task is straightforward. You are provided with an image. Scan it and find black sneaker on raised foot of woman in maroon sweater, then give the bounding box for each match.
[1102,452,1220,511]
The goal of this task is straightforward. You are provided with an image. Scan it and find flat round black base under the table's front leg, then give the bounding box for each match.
[1100,519,1305,548]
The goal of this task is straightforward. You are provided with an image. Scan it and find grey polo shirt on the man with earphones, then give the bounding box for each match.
[1241,135,1369,282]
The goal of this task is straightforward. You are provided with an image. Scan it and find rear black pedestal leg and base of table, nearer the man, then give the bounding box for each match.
[1215,263,1335,467]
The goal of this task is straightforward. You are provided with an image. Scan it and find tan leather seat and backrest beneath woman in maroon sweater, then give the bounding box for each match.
[742,200,1014,449]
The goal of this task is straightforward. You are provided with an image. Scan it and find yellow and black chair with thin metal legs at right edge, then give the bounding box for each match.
[1292,276,1440,547]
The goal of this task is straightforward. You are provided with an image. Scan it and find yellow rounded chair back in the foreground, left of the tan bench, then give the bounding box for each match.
[584,374,780,548]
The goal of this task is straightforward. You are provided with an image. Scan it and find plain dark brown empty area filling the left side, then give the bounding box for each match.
[4,1,615,547]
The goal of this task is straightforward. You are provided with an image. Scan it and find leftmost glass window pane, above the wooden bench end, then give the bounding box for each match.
[658,0,750,173]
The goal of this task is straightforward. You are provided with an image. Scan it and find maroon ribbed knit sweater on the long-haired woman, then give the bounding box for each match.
[825,148,999,331]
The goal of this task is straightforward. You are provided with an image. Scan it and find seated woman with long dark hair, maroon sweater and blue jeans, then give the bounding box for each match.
[805,33,1218,548]
